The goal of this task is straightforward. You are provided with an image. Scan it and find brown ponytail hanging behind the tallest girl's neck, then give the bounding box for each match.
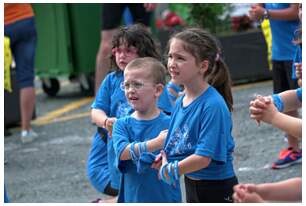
[207,57,233,112]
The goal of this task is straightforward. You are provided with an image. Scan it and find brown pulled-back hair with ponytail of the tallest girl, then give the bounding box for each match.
[167,28,233,111]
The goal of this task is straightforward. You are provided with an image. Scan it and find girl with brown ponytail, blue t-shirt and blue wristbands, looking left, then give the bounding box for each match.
[153,28,238,202]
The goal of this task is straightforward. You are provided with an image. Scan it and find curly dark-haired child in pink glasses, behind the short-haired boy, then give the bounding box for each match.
[87,24,177,201]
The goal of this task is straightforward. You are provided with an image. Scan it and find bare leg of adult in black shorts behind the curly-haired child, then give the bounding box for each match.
[95,29,117,94]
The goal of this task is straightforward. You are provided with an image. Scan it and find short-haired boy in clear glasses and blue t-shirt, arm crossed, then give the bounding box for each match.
[113,57,181,203]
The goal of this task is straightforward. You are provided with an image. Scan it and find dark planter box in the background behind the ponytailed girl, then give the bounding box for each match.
[158,30,272,84]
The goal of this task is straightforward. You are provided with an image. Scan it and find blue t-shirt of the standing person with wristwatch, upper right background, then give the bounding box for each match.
[265,3,299,61]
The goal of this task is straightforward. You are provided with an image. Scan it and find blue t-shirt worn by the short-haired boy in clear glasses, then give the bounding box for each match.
[113,112,181,202]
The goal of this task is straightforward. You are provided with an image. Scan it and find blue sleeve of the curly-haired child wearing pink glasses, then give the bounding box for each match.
[91,74,111,114]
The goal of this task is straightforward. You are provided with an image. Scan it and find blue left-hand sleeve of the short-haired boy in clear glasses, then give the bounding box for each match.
[113,119,130,172]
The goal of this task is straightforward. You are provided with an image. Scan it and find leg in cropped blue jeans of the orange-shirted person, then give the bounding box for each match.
[8,18,37,136]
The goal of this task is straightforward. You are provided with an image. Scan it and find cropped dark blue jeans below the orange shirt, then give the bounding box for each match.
[4,17,37,88]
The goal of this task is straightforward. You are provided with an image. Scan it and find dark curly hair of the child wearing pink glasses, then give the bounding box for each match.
[111,24,161,71]
